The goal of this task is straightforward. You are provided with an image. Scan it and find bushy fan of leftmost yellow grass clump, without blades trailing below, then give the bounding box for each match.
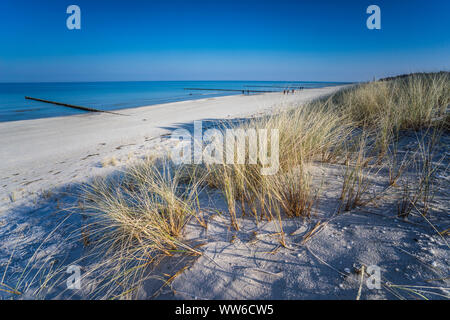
[85,160,201,254]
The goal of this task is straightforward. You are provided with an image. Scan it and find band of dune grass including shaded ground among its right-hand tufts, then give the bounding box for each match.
[11,73,450,298]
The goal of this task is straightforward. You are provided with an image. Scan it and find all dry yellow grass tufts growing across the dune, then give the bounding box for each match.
[77,73,450,298]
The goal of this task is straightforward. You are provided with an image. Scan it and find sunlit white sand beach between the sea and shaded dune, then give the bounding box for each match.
[0,85,347,209]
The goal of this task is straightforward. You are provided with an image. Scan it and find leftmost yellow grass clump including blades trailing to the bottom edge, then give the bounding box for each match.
[76,160,200,297]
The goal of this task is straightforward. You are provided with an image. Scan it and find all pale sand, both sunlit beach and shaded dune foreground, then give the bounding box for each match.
[0,83,449,299]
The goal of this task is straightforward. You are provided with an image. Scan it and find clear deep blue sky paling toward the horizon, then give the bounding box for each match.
[0,0,450,82]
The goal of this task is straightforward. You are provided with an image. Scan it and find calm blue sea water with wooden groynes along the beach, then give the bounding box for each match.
[0,81,342,122]
